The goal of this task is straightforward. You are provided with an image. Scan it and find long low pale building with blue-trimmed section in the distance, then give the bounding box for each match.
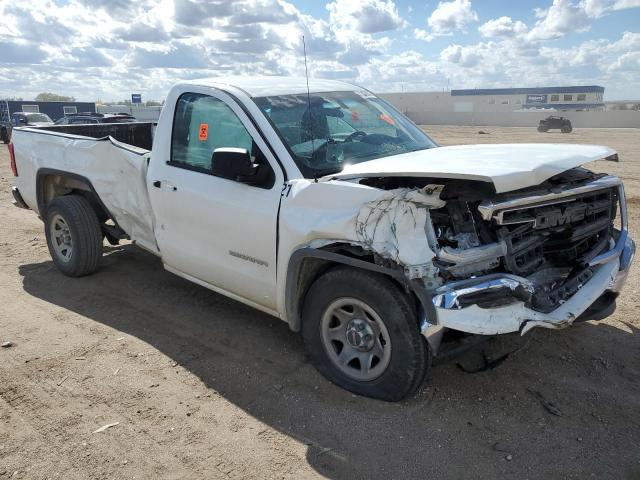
[380,85,605,113]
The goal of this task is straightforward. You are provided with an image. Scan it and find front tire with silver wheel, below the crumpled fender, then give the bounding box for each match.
[302,267,431,401]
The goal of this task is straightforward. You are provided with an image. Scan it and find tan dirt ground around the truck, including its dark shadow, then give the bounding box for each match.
[0,127,640,480]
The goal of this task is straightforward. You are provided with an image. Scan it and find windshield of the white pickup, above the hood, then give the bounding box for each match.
[254,91,437,178]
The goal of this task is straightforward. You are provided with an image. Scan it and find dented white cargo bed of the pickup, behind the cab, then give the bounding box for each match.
[12,123,157,252]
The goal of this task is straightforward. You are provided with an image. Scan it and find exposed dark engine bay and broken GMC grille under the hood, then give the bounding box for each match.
[360,168,618,312]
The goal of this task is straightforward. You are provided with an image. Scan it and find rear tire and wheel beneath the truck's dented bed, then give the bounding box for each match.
[45,195,102,277]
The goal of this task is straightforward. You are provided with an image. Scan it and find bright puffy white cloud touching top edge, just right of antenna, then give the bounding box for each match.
[327,0,405,34]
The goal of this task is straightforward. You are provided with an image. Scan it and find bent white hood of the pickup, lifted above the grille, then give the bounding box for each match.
[327,143,616,193]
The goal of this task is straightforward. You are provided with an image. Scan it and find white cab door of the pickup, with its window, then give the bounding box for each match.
[147,89,284,310]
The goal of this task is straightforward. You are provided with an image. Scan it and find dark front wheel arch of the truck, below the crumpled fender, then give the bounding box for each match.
[285,243,417,332]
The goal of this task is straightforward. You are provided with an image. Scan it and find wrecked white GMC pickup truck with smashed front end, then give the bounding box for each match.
[10,77,635,401]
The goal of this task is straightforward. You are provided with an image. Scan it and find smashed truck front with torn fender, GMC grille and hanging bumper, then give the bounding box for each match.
[357,168,635,350]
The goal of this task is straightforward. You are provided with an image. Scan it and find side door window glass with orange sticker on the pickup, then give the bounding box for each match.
[170,93,255,173]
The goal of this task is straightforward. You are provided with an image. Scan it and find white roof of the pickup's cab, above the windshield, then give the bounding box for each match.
[179,76,363,97]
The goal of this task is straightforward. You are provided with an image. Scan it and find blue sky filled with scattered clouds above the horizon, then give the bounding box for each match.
[0,0,640,100]
